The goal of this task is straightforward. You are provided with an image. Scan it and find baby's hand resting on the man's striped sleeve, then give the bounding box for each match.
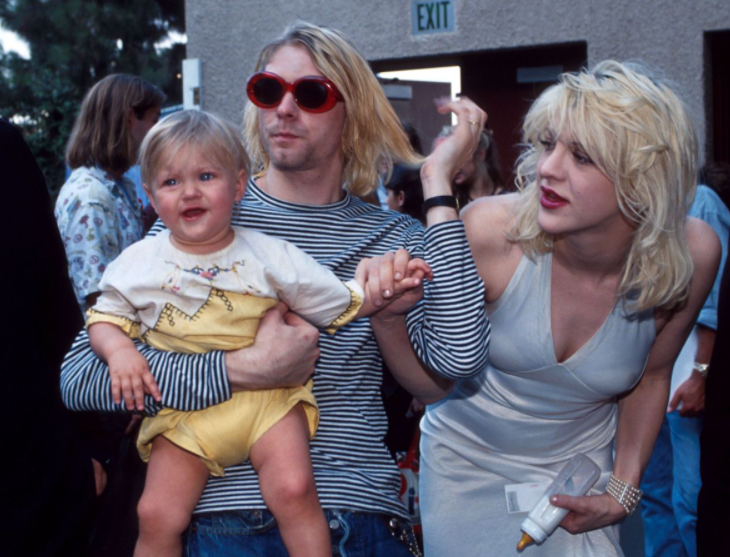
[107,346,162,412]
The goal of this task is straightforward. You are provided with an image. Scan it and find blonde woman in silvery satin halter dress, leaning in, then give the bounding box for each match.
[421,61,720,557]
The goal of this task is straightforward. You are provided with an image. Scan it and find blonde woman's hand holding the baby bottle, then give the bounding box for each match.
[550,493,626,534]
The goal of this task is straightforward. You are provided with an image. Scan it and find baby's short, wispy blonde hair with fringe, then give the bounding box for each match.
[139,110,250,189]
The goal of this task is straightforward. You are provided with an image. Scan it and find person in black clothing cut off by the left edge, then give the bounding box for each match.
[0,120,98,557]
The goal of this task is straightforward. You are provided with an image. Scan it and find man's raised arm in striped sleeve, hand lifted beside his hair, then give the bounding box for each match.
[390,98,489,380]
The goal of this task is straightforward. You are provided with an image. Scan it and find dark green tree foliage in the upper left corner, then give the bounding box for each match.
[0,0,185,195]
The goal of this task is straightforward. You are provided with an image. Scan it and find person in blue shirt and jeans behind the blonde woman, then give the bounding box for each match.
[641,180,730,557]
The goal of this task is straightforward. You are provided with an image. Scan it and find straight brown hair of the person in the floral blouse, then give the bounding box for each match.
[66,74,166,173]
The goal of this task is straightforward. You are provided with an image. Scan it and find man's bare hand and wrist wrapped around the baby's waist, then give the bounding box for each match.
[225,302,319,391]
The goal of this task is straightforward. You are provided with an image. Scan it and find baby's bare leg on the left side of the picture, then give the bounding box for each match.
[134,436,210,557]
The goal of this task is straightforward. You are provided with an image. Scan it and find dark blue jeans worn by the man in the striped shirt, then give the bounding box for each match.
[184,510,410,557]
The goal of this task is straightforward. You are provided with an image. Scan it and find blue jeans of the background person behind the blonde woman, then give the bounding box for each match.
[641,411,702,557]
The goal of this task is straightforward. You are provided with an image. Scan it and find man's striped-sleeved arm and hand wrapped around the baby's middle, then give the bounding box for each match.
[61,304,319,414]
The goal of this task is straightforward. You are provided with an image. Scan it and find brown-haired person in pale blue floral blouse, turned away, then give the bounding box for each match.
[55,74,165,311]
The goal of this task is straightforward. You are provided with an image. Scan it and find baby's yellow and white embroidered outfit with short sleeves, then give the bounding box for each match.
[87,229,363,476]
